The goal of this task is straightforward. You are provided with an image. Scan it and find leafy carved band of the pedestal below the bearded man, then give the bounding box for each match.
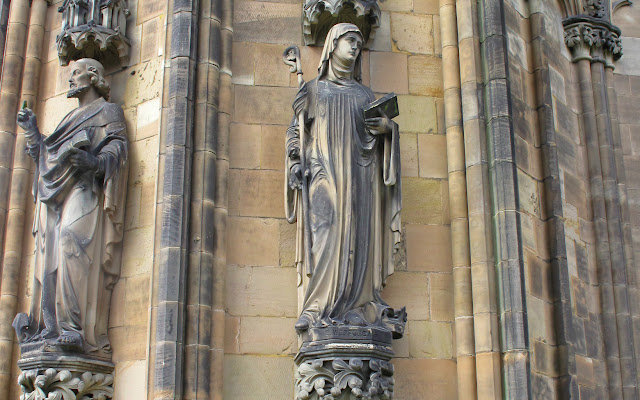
[18,368,113,400]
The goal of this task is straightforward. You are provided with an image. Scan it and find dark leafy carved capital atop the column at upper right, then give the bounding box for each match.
[563,16,622,66]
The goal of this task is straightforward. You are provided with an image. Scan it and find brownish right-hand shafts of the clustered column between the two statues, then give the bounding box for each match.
[183,0,231,399]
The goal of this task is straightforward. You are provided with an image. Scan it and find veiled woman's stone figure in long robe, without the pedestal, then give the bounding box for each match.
[285,24,406,337]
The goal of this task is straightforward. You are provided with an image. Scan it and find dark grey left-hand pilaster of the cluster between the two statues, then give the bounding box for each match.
[149,0,200,399]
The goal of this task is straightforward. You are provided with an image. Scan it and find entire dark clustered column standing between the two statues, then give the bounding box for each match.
[148,0,233,399]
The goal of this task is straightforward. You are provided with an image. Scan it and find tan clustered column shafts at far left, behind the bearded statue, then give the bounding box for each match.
[0,1,47,397]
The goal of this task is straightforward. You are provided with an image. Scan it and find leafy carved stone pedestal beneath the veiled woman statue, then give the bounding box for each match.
[295,326,394,400]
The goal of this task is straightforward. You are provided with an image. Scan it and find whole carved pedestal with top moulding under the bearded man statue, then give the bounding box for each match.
[18,354,114,400]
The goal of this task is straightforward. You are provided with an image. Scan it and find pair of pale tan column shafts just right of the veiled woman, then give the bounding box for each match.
[440,0,503,399]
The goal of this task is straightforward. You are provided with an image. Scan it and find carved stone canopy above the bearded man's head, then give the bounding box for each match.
[56,0,131,66]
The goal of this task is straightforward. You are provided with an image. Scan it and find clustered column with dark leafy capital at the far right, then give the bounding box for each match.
[563,7,640,399]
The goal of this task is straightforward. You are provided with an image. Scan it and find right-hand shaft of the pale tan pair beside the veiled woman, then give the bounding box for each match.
[456,0,502,399]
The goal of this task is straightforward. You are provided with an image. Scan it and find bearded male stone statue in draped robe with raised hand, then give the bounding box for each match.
[13,58,128,362]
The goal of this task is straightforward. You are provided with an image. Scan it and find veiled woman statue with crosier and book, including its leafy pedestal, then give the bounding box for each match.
[283,23,407,400]
